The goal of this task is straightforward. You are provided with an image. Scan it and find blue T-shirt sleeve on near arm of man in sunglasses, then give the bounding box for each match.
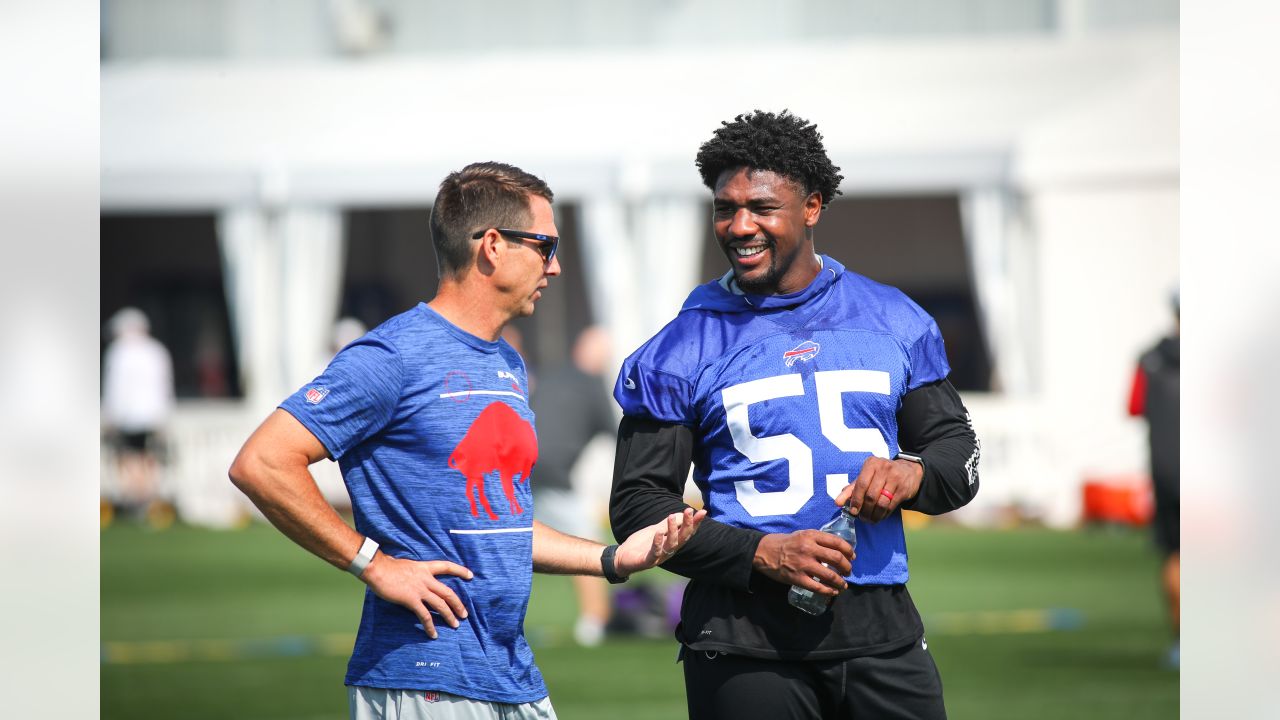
[280,334,404,460]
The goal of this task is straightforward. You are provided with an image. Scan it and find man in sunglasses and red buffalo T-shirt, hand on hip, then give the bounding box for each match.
[229,163,701,720]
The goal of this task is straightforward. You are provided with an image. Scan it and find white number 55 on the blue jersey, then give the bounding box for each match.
[721,370,890,516]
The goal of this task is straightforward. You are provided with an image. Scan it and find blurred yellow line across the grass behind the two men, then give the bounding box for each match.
[101,607,1084,665]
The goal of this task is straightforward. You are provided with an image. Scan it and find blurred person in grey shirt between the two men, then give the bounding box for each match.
[531,327,616,647]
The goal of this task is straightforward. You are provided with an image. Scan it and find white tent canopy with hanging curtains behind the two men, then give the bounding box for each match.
[101,31,1178,523]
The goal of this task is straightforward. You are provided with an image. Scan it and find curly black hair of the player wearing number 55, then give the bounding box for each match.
[695,110,845,208]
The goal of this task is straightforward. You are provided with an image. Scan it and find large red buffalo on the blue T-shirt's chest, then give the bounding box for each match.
[449,402,538,520]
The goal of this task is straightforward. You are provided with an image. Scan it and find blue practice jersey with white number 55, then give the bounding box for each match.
[614,256,950,585]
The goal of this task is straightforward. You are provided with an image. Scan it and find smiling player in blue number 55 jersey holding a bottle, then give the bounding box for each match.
[609,111,978,720]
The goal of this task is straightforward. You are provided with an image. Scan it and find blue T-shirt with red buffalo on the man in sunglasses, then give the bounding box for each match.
[280,304,547,703]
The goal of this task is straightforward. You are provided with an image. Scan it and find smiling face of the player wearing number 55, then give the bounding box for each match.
[712,168,822,295]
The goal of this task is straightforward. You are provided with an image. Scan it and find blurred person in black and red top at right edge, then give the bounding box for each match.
[1129,291,1181,667]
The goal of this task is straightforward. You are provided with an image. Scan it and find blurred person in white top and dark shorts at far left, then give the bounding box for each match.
[102,307,174,527]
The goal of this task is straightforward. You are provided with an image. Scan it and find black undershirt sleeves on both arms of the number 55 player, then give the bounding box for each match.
[609,379,978,591]
